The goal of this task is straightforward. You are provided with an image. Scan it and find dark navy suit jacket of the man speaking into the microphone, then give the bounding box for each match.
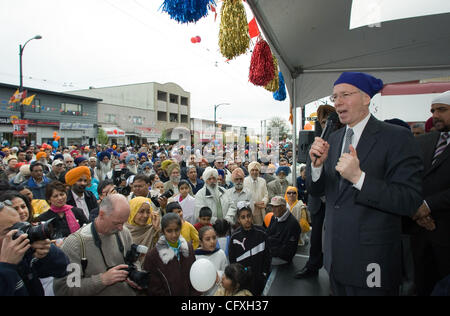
[307,116,423,290]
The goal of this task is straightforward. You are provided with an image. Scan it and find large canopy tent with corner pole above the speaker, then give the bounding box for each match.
[247,0,450,176]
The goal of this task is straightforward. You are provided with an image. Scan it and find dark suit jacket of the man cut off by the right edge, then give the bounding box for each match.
[408,132,450,246]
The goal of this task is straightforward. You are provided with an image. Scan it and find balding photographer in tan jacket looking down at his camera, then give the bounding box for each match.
[54,194,136,296]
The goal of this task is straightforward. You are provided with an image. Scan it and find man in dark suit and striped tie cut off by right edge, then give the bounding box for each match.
[409,91,450,295]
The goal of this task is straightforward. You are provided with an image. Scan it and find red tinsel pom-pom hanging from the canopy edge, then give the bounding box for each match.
[248,39,275,86]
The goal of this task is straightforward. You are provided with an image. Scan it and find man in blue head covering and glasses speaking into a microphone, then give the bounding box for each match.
[307,72,423,295]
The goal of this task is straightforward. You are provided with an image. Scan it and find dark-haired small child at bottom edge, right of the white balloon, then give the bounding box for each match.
[214,263,252,296]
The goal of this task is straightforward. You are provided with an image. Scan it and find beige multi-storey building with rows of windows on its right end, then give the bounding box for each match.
[70,82,191,145]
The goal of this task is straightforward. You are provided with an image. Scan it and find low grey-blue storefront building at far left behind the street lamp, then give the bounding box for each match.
[0,83,101,145]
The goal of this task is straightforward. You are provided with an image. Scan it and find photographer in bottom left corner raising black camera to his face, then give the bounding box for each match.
[0,200,69,296]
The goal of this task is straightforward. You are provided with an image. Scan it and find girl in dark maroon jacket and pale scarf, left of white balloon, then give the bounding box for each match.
[144,213,200,296]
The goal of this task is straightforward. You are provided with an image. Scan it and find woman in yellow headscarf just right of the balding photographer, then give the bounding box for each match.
[125,196,161,263]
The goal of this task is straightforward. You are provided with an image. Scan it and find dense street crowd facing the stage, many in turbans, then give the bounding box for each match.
[0,129,307,295]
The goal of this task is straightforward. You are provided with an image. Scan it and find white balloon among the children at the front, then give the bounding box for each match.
[189,258,217,292]
